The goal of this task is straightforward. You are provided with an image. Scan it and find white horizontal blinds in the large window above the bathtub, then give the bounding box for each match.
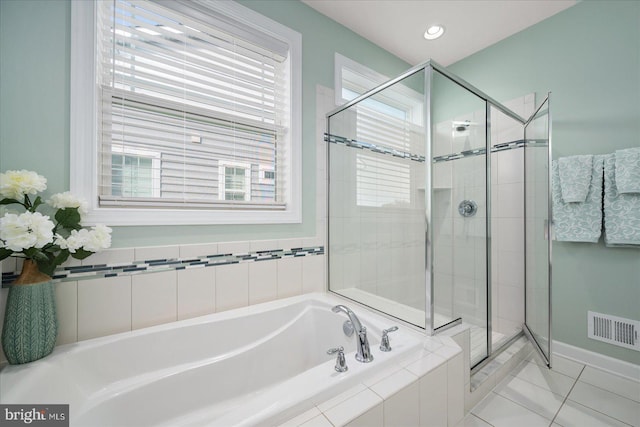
[97,0,291,209]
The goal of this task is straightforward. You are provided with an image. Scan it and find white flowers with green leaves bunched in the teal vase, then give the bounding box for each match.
[0,170,111,276]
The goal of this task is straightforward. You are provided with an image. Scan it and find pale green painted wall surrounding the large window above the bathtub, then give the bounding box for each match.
[0,0,409,247]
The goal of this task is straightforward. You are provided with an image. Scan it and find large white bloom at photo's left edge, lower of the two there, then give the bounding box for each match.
[0,212,54,252]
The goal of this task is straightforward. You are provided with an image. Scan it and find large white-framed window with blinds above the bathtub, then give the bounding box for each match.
[72,0,301,225]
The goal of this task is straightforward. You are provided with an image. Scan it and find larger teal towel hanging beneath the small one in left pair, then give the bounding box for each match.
[551,156,603,243]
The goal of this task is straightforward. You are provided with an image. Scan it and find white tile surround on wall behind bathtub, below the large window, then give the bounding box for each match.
[0,86,334,363]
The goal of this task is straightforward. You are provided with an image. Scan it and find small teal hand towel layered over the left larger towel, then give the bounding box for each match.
[558,154,593,203]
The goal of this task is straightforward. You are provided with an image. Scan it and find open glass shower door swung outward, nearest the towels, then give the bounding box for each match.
[524,94,551,367]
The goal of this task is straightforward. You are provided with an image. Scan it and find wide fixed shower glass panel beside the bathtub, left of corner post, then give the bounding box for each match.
[328,71,426,328]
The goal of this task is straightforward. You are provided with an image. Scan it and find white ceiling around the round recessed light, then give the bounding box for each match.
[301,0,576,66]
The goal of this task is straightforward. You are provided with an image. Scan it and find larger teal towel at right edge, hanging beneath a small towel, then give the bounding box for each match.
[604,154,640,246]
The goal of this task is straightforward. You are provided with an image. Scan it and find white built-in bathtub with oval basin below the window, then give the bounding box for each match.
[0,294,422,427]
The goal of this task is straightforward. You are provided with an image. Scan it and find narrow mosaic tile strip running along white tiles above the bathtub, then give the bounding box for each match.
[2,246,324,288]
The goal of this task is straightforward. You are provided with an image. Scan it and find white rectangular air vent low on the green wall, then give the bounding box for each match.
[587,311,640,351]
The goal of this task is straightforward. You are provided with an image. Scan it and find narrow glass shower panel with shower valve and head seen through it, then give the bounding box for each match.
[431,73,489,366]
